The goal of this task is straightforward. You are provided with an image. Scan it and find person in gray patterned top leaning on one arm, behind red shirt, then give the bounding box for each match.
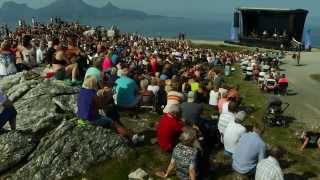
[156,128,198,180]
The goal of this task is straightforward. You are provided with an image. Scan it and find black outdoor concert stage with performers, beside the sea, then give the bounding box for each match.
[229,8,308,49]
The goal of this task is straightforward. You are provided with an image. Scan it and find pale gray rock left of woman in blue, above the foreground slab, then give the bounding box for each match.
[8,80,79,134]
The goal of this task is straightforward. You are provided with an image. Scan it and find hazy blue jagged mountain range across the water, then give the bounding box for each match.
[0,0,162,24]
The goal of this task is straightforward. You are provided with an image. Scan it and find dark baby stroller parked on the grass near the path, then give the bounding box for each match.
[264,96,289,127]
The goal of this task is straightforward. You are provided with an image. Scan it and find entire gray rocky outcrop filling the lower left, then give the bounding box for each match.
[0,72,130,180]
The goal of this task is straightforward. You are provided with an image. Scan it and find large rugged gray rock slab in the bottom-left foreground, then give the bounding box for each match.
[12,120,129,180]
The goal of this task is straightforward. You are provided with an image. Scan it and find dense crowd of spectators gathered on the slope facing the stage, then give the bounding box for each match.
[0,19,316,180]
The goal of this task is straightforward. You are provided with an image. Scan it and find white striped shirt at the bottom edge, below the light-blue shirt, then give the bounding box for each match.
[255,156,283,180]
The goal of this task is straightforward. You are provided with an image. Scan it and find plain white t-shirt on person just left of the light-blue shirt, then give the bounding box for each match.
[223,122,246,153]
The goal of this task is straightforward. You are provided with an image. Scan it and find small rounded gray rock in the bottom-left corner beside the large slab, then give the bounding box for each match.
[0,131,37,173]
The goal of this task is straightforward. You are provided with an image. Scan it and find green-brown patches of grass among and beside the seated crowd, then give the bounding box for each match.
[76,45,320,180]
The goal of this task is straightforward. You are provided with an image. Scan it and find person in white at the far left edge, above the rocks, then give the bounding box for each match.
[0,40,17,76]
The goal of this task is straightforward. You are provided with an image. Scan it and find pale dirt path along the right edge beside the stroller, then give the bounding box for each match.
[281,52,320,128]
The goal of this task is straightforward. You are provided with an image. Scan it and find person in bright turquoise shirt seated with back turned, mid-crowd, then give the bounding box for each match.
[115,67,140,109]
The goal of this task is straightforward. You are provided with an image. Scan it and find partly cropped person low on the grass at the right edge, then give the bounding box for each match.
[300,131,320,151]
